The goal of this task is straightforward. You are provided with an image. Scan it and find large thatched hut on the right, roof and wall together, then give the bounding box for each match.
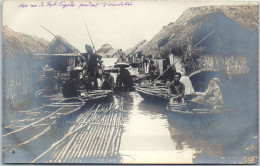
[141,5,258,76]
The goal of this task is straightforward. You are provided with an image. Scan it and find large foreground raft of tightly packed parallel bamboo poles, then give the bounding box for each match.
[32,104,124,163]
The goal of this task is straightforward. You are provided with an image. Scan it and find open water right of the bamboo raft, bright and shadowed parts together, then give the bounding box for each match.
[120,92,258,163]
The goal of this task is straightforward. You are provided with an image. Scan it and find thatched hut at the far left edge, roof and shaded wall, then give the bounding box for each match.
[2,25,49,107]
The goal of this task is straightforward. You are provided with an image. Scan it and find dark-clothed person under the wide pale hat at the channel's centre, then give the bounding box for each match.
[116,66,134,90]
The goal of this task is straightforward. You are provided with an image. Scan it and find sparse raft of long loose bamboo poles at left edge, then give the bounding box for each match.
[2,101,84,152]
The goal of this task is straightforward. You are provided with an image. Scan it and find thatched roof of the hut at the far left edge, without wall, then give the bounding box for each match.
[2,25,49,57]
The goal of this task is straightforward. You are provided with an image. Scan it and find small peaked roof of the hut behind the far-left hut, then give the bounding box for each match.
[46,36,80,55]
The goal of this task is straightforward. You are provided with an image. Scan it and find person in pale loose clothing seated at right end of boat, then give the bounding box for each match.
[191,78,224,109]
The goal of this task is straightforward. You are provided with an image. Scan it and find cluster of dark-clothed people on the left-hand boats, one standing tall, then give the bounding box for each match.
[62,46,133,97]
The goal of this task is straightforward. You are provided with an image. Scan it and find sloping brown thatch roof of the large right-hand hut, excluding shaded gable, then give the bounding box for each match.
[141,5,258,56]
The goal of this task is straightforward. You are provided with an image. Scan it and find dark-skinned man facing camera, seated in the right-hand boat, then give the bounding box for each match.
[168,72,185,103]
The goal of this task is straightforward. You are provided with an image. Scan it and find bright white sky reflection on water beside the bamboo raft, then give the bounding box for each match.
[120,92,192,163]
